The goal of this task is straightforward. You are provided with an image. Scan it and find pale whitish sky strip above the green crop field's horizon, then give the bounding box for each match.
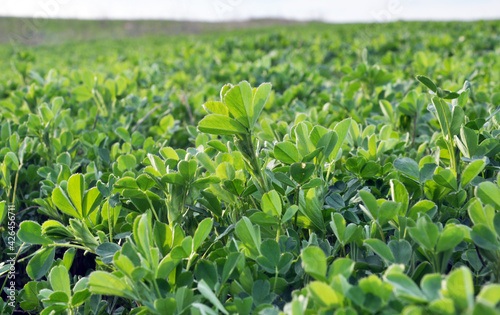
[0,0,500,23]
